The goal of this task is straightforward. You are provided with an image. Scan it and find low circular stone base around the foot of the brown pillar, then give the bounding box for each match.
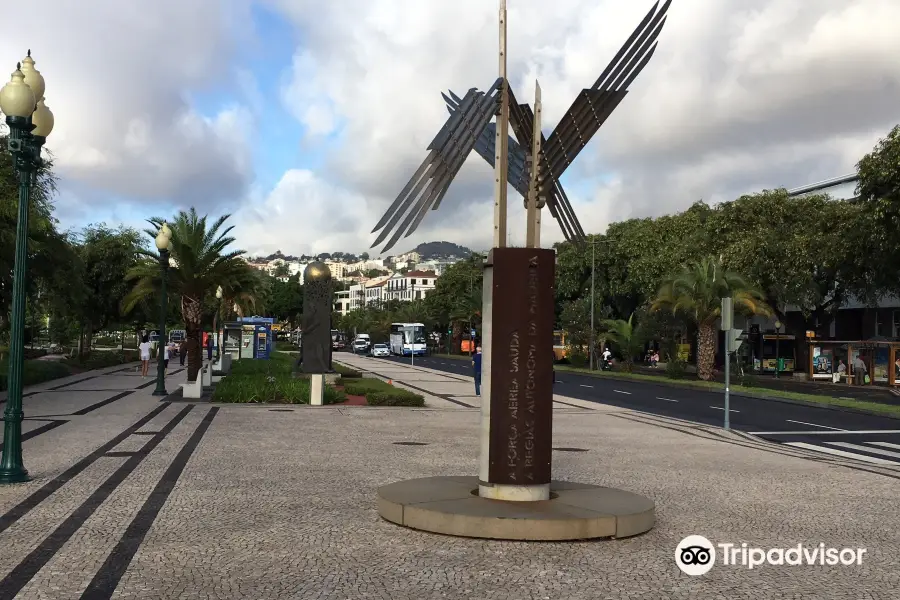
[378,477,655,541]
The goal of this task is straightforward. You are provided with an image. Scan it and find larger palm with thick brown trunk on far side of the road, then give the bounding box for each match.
[651,256,772,381]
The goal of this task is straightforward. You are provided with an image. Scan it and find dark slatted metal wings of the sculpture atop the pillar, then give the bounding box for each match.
[372,0,672,252]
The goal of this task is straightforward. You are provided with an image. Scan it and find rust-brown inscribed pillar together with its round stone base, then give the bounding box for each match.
[378,248,655,541]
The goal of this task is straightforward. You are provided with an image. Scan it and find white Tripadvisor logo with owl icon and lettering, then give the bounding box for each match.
[675,535,866,576]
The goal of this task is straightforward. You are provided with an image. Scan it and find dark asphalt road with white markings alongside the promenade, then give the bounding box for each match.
[384,356,900,464]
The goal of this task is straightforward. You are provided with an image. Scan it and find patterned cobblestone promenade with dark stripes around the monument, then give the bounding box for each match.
[0,358,900,600]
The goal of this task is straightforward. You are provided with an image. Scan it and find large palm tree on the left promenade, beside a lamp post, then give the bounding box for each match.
[122,208,256,381]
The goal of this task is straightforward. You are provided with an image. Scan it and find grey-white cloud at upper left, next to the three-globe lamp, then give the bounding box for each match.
[0,0,253,214]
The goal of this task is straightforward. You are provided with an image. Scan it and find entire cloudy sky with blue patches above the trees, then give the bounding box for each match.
[0,0,900,256]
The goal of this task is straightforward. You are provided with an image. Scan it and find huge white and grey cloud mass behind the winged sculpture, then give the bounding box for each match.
[271,0,900,250]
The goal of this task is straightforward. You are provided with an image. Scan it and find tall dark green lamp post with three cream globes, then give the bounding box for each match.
[0,50,53,483]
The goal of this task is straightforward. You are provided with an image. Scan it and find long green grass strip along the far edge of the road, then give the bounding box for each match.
[556,365,900,417]
